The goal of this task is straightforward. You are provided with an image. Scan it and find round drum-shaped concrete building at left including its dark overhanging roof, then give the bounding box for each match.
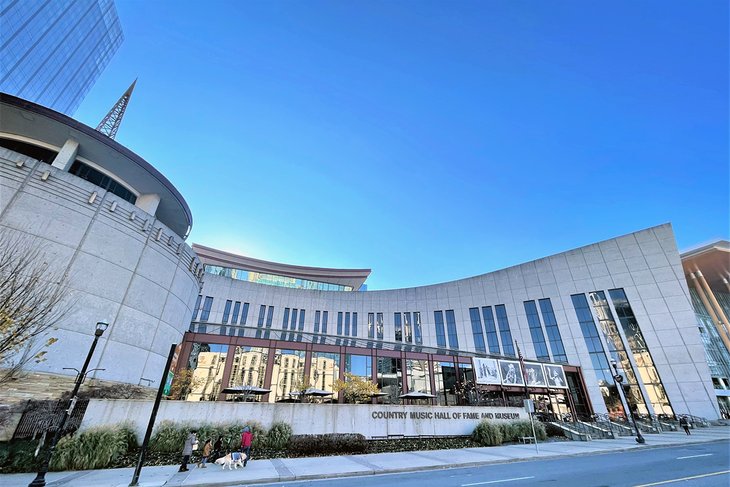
[0,94,203,384]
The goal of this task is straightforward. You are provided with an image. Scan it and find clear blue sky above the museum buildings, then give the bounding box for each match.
[75,0,730,290]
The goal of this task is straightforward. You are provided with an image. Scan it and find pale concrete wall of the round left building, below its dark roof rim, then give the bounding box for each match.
[0,148,199,384]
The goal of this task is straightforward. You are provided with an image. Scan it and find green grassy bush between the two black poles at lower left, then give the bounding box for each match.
[51,425,137,470]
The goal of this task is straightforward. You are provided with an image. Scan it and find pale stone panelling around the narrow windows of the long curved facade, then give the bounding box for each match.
[196,224,719,418]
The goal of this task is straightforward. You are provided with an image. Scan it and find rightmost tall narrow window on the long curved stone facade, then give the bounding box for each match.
[608,289,674,416]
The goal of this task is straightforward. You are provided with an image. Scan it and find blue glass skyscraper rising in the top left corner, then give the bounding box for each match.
[0,0,123,115]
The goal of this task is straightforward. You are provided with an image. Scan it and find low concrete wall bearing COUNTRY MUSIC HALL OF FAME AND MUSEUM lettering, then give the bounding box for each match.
[81,399,529,439]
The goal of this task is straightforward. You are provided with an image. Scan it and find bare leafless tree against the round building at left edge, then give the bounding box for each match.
[0,229,71,385]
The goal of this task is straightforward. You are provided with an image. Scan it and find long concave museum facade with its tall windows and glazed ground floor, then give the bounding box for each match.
[178,224,718,418]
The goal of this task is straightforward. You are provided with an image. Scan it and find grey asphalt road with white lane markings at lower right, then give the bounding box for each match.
[247,441,730,487]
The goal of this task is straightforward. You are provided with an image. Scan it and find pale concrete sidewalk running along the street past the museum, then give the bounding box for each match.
[0,426,730,487]
